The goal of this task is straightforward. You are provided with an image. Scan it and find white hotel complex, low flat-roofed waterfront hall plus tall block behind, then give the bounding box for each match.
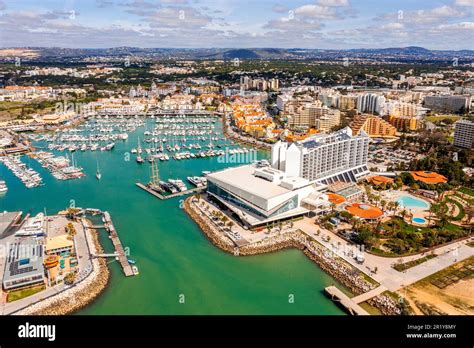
[207,128,369,228]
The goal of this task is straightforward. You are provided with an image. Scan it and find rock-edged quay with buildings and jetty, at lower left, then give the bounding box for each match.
[0,208,138,314]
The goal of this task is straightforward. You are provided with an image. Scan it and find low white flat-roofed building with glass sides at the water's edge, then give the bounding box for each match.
[207,163,330,227]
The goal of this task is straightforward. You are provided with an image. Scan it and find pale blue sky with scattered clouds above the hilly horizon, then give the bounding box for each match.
[0,0,474,50]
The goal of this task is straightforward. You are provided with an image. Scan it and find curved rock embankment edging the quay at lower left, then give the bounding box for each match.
[14,220,110,315]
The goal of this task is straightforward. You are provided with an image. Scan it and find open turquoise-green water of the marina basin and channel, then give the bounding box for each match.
[0,121,344,315]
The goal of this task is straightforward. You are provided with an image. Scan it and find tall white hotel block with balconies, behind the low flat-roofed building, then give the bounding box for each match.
[271,127,369,184]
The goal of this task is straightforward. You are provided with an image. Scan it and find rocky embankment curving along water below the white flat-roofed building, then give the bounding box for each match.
[184,196,399,315]
